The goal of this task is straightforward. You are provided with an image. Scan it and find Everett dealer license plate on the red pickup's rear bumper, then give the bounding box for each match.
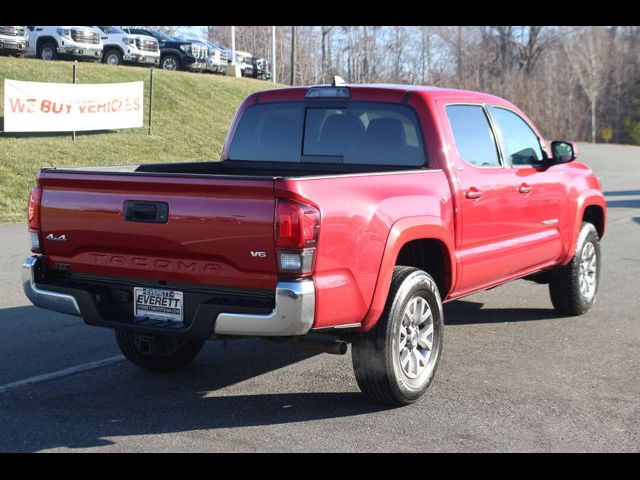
[133,287,184,323]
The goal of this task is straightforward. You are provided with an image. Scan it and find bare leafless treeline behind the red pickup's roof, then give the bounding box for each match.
[171,26,640,144]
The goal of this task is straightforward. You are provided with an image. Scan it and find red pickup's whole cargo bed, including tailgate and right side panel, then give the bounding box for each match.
[33,161,444,328]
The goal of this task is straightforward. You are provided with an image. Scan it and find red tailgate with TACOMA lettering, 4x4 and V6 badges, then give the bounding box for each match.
[38,170,277,289]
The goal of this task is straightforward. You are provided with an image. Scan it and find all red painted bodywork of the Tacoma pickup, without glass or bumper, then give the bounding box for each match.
[39,85,606,330]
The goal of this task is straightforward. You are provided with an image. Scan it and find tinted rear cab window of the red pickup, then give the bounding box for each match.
[228,101,427,168]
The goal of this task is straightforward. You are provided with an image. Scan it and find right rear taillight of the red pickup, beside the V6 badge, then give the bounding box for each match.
[275,199,320,276]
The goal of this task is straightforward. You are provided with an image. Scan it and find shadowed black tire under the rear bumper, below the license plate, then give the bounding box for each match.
[115,330,204,372]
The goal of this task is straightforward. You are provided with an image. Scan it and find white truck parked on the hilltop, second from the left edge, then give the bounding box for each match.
[27,25,102,61]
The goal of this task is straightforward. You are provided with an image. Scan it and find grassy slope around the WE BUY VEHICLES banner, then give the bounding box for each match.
[0,57,282,222]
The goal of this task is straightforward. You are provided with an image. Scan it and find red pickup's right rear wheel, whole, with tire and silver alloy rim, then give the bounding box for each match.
[352,266,443,406]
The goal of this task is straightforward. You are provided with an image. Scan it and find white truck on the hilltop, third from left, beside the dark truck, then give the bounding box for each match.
[95,26,160,65]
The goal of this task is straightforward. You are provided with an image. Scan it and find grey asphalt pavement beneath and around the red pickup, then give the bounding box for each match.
[0,144,640,452]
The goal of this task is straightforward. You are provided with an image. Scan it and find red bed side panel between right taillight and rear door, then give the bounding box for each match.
[275,170,453,328]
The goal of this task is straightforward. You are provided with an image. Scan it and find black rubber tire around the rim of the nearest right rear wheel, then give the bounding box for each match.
[351,266,444,406]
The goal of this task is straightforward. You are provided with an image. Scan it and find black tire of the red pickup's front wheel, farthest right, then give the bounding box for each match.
[549,222,600,315]
